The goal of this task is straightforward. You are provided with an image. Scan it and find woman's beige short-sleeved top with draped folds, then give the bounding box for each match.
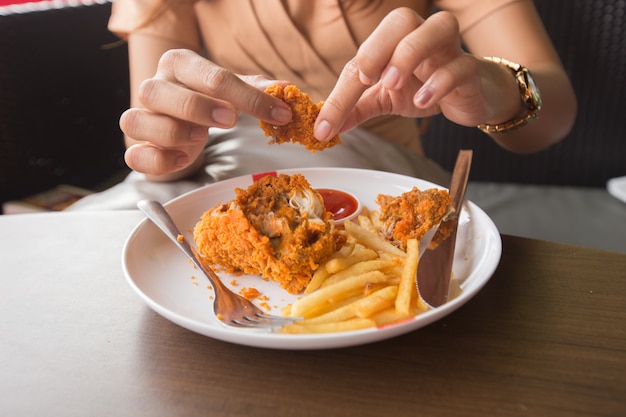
[109,0,516,155]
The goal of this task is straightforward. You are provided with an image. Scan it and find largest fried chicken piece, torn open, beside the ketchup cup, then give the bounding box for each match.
[194,174,335,294]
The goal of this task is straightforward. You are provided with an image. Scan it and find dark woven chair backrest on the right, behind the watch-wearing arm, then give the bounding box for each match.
[424,0,626,187]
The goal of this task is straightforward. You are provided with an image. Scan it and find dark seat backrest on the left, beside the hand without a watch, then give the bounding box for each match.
[0,2,129,202]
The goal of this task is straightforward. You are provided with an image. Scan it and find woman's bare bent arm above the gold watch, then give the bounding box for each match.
[463,2,577,152]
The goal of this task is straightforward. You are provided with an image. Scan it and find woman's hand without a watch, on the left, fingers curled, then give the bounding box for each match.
[120,49,291,180]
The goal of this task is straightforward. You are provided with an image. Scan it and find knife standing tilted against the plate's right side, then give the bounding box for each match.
[416,150,473,307]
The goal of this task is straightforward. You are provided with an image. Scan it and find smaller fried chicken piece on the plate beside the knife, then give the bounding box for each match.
[376,187,451,250]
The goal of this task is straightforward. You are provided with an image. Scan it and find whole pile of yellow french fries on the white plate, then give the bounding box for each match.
[281,210,428,334]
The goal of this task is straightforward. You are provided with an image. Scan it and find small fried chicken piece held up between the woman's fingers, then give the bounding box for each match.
[260,85,341,153]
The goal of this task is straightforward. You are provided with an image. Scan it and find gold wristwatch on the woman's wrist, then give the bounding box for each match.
[477,56,541,133]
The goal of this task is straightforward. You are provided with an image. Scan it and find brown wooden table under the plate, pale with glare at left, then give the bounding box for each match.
[0,211,626,417]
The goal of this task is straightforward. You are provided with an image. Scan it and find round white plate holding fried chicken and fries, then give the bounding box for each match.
[122,168,502,349]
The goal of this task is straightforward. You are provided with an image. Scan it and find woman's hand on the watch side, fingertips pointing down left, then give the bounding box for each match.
[315,8,521,140]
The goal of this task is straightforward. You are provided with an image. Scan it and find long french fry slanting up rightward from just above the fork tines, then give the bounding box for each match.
[291,271,387,318]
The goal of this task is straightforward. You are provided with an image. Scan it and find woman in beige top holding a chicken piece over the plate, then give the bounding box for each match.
[72,0,576,208]
